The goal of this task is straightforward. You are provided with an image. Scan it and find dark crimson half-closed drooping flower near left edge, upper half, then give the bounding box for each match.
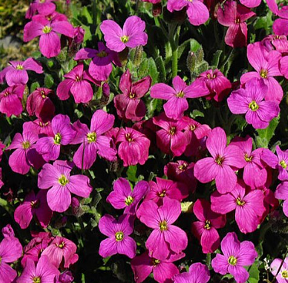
[26,87,55,121]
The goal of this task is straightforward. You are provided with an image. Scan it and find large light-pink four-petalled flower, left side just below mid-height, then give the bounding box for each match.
[38,160,92,212]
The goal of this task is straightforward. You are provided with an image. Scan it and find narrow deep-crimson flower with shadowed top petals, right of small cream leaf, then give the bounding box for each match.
[192,199,226,254]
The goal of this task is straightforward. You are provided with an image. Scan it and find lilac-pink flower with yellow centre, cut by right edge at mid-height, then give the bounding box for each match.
[261,145,288,181]
